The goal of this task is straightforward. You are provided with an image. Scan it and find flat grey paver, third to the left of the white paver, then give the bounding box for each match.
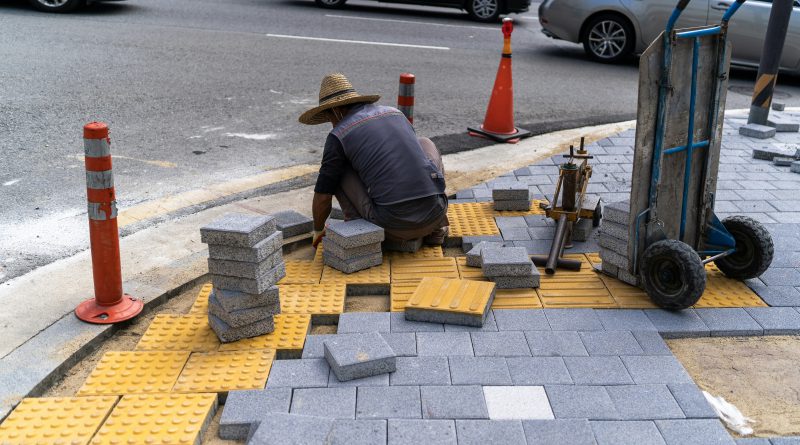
[289,387,356,419]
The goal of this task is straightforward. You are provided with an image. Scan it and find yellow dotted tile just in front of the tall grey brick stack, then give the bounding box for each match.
[173,349,275,393]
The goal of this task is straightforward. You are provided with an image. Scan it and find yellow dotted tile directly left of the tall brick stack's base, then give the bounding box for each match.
[136,313,220,352]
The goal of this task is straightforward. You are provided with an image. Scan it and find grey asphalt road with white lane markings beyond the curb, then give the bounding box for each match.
[0,0,800,282]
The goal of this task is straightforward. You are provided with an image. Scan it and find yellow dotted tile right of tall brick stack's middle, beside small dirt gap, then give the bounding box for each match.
[278,284,347,315]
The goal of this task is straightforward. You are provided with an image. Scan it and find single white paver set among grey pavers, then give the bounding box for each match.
[483,386,553,420]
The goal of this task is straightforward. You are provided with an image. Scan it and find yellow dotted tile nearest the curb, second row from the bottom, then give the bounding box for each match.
[78,351,189,396]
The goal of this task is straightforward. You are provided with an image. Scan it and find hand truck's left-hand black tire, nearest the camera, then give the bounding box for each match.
[640,239,706,310]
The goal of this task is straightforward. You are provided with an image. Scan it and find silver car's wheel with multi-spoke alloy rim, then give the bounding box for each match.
[583,14,635,63]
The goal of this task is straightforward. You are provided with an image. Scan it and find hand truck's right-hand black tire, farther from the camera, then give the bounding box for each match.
[714,216,775,280]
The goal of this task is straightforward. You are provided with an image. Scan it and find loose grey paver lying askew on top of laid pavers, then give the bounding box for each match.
[323,332,395,382]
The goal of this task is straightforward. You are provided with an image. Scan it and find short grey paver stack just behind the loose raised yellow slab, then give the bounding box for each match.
[481,247,539,289]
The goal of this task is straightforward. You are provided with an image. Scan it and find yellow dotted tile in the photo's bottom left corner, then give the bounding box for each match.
[0,396,117,445]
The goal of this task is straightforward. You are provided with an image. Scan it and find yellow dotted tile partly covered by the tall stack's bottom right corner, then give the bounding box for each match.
[219,314,311,351]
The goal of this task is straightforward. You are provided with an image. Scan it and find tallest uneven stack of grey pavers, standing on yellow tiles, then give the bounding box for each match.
[200,213,286,343]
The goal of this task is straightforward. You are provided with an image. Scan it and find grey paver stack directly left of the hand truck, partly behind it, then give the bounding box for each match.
[598,201,638,286]
